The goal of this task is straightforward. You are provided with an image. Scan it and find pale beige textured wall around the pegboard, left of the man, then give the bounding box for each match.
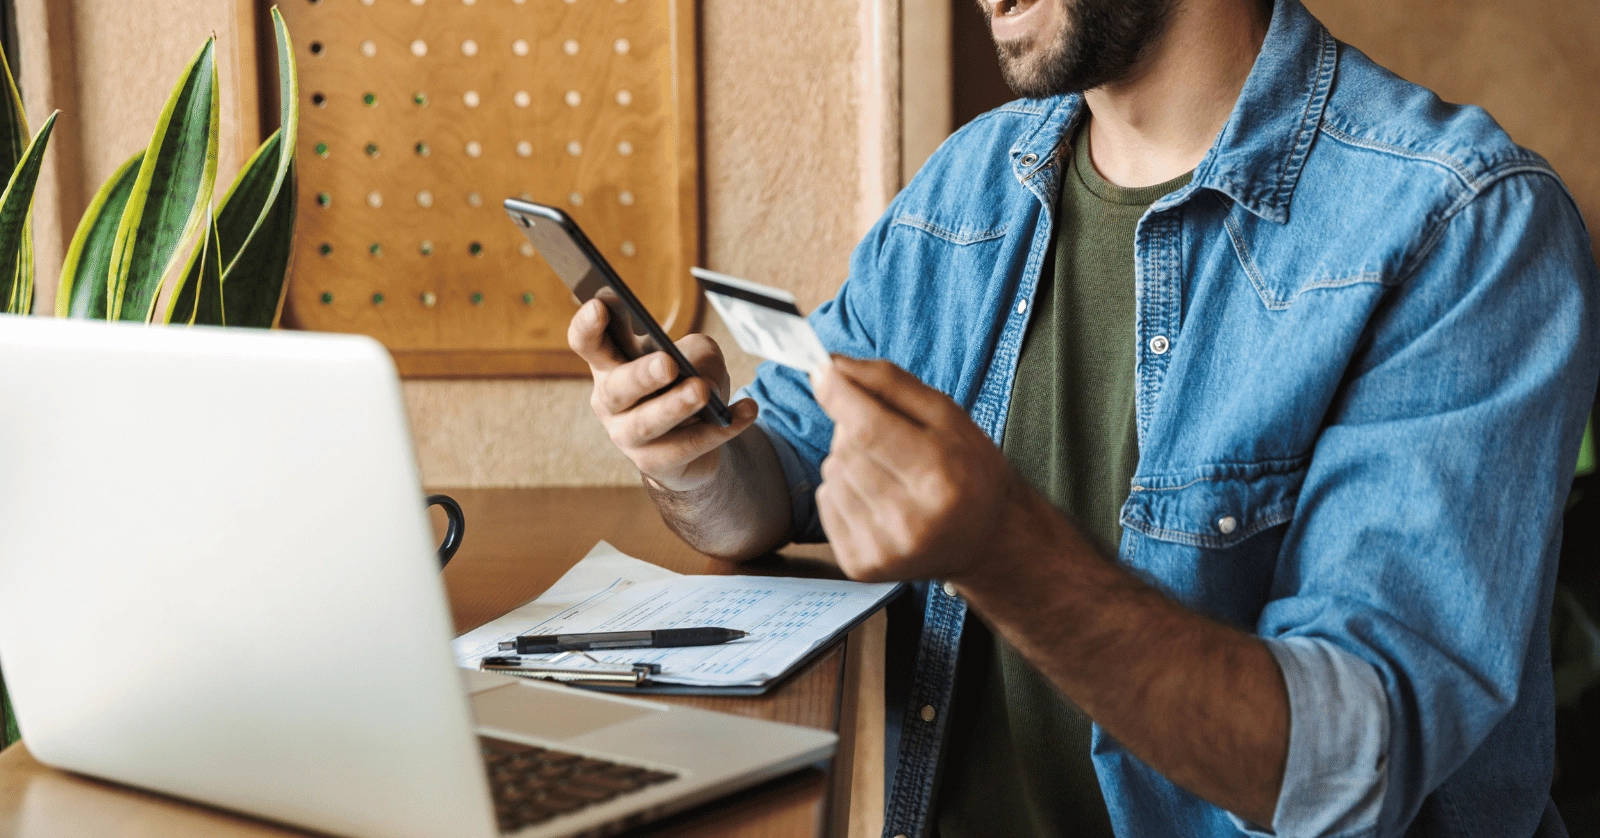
[16,0,902,486]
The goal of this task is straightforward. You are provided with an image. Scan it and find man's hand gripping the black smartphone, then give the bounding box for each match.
[566,299,757,491]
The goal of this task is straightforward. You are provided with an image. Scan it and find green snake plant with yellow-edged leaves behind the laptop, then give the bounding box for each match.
[0,8,299,747]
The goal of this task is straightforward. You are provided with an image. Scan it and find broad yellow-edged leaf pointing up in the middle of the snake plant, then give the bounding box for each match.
[109,38,219,321]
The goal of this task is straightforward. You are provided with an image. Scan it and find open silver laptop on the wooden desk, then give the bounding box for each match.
[0,315,835,838]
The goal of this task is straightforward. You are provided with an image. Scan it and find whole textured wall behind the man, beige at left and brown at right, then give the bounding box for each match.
[16,0,1600,486]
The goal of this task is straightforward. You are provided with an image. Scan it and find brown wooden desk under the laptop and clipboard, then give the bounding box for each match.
[0,488,885,838]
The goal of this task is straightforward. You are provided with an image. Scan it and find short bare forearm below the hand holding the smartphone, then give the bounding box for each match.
[645,425,790,561]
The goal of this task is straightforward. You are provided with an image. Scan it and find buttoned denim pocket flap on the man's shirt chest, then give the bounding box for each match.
[1122,457,1307,549]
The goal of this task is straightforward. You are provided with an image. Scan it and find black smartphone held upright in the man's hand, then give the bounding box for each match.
[506,198,733,427]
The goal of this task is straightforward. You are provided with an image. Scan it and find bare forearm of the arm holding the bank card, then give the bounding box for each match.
[955,482,1290,825]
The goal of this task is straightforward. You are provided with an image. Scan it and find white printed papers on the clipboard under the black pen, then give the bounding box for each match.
[454,542,899,688]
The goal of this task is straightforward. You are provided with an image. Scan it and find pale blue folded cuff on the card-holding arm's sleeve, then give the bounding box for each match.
[1229,636,1389,838]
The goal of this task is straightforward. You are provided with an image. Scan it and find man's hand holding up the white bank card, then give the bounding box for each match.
[811,355,1024,581]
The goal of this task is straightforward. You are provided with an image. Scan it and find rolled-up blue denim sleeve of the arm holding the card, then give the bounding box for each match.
[1238,171,1600,838]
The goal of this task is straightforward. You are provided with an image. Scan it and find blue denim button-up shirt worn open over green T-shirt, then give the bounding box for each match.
[746,0,1600,838]
